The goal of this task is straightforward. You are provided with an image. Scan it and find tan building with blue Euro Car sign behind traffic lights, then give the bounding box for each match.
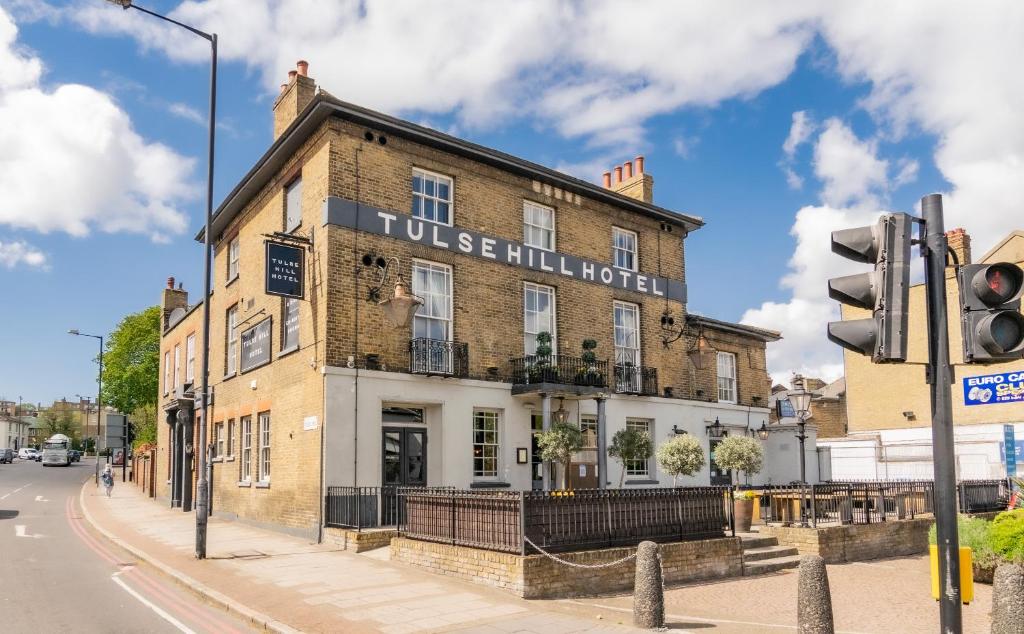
[822,228,1024,478]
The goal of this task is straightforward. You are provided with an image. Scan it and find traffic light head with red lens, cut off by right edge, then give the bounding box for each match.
[956,262,1024,364]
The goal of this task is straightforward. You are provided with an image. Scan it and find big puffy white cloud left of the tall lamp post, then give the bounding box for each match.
[0,8,196,241]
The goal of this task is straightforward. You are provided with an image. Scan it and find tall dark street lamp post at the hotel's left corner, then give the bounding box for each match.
[106,0,217,559]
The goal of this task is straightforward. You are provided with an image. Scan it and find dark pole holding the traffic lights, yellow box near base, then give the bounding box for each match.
[921,194,963,634]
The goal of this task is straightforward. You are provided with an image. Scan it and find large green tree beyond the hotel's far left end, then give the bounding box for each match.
[103,306,162,413]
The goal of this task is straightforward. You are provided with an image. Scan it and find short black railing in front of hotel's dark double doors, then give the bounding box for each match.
[324,487,452,531]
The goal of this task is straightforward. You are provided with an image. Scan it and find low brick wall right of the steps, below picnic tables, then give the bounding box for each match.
[759,517,934,563]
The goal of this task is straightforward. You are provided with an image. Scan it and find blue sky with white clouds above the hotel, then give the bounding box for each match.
[0,0,1024,403]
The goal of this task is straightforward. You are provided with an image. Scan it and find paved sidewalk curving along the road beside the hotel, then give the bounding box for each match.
[81,483,636,634]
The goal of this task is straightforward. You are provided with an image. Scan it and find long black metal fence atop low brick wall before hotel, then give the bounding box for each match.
[398,487,732,554]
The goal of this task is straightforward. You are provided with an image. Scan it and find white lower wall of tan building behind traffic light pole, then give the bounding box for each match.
[819,422,1024,479]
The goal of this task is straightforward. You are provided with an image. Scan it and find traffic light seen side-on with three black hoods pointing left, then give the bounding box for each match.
[828,213,911,364]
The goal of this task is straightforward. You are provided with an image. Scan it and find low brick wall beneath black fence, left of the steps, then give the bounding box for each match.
[391,538,743,599]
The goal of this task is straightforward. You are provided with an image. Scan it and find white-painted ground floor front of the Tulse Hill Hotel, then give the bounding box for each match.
[324,368,820,490]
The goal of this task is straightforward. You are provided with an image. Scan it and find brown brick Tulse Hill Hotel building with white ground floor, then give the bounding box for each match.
[157,62,794,534]
